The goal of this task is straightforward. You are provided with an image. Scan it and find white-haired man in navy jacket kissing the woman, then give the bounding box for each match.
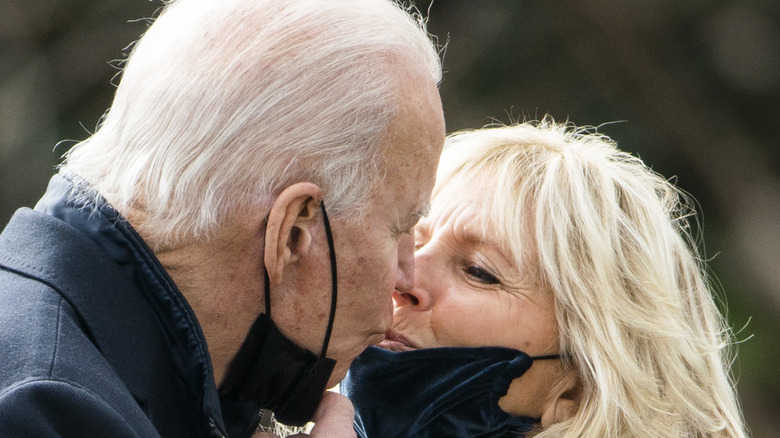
[0,0,444,437]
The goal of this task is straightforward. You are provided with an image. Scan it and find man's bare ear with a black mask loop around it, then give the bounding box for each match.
[264,182,322,284]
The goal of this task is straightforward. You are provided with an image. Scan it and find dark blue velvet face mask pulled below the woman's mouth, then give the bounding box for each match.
[340,347,559,438]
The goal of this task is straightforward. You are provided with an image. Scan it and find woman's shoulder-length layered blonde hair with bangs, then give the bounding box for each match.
[434,117,746,438]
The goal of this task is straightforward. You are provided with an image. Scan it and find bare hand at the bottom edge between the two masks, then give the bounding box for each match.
[252,391,357,438]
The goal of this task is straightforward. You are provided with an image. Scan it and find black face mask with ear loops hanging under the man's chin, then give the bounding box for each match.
[219,204,338,426]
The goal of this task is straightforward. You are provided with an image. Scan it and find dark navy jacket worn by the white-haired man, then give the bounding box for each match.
[0,176,241,438]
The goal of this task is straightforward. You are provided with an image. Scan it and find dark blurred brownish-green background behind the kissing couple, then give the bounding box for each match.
[0,0,780,437]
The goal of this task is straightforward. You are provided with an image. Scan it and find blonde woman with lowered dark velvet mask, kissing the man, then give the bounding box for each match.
[342,118,745,438]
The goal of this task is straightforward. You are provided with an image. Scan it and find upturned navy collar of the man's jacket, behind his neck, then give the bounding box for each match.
[4,175,225,430]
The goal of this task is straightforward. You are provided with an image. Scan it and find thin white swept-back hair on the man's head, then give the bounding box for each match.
[61,0,441,249]
